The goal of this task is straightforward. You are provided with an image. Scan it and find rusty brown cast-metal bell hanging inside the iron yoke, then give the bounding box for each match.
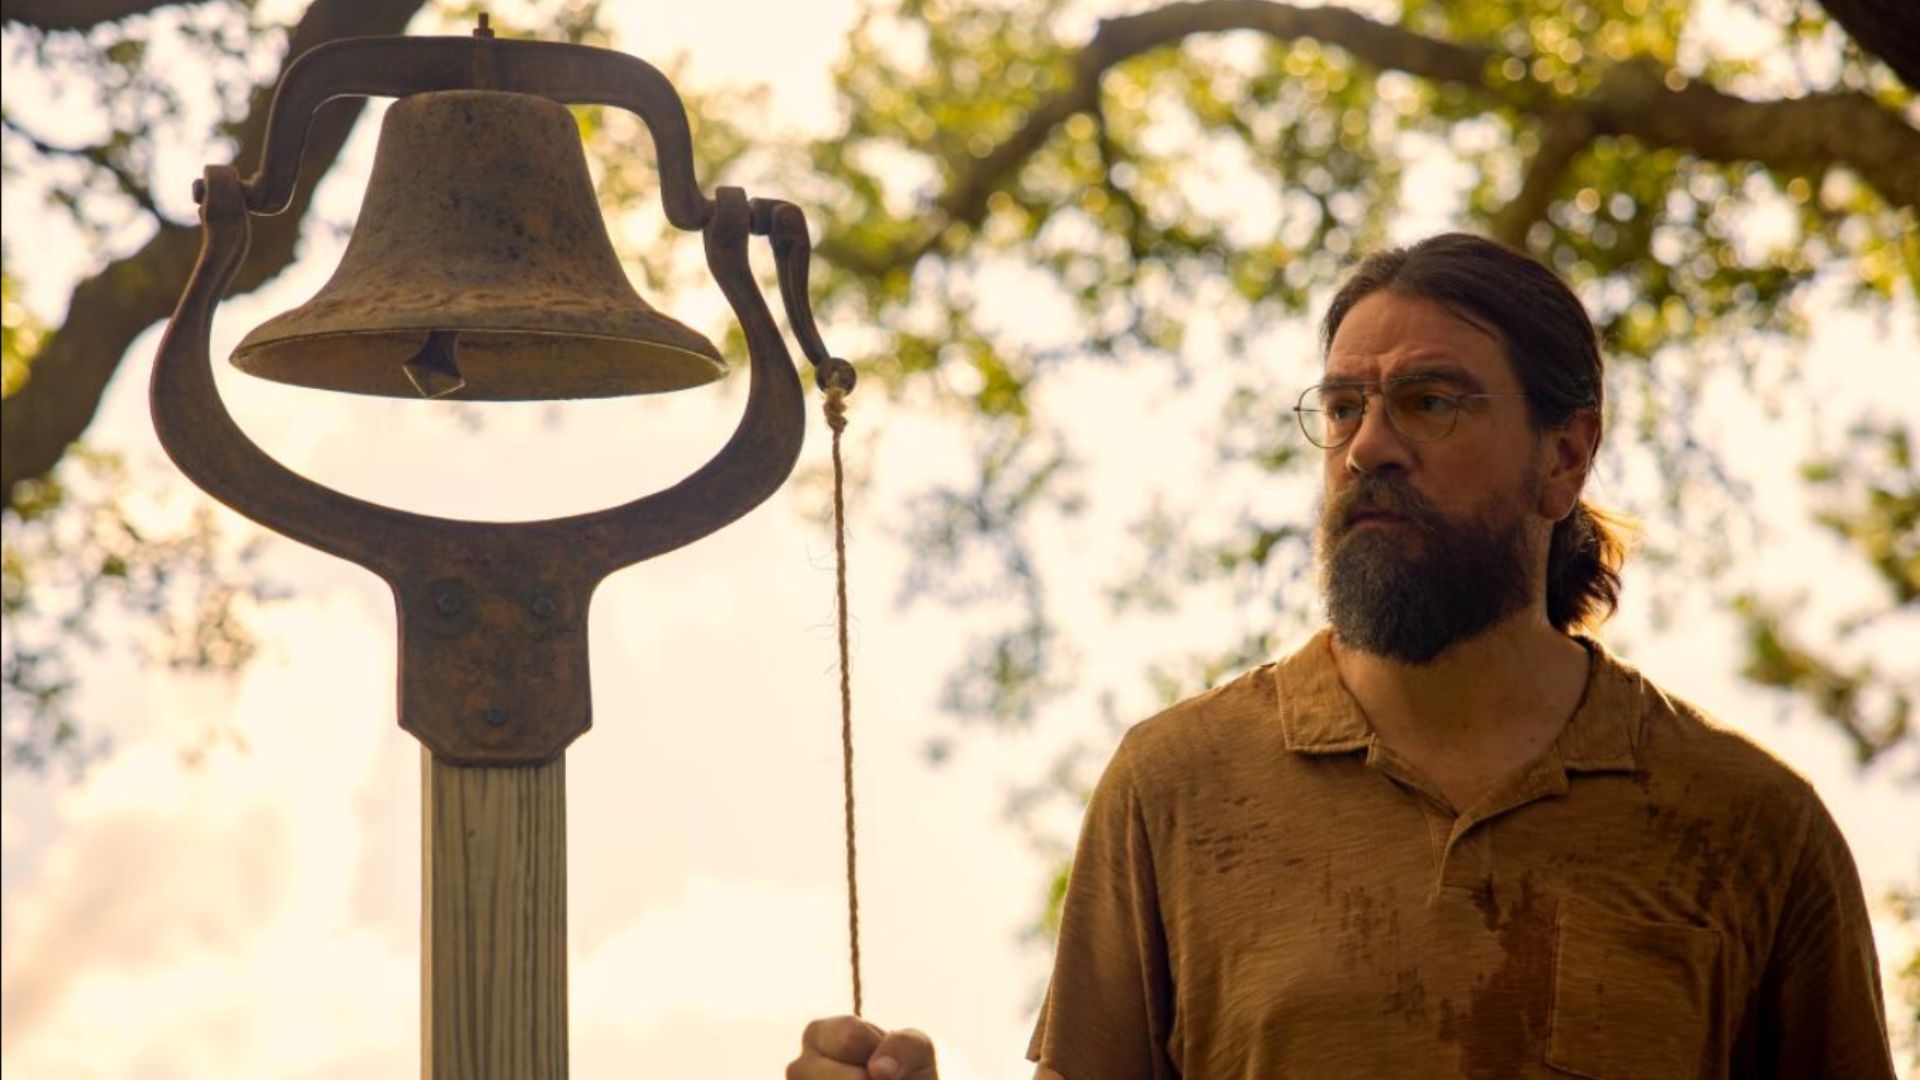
[232,90,726,402]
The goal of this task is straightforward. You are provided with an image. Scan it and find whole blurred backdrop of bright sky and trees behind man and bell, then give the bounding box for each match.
[0,0,1920,1080]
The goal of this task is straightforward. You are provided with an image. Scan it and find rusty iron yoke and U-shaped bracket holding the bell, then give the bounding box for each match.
[161,35,852,765]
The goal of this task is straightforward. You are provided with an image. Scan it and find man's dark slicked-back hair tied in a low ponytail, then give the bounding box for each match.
[1321,233,1628,632]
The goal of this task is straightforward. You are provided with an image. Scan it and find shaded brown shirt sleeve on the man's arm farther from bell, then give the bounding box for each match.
[1757,780,1893,1080]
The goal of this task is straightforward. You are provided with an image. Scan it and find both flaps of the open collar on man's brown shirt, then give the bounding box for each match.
[1275,628,1640,773]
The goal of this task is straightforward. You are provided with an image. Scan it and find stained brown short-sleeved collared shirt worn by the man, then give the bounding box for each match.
[1027,632,1893,1080]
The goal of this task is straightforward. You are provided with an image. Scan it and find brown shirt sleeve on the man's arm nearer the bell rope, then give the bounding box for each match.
[1027,740,1179,1080]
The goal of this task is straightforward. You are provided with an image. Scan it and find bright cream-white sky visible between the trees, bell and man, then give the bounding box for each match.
[0,0,1920,1080]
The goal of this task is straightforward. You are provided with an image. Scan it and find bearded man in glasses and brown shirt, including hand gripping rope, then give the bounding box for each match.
[787,234,1893,1080]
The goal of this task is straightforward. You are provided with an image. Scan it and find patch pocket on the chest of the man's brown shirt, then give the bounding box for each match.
[1548,899,1720,1080]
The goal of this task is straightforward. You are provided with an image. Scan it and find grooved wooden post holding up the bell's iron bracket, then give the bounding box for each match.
[420,748,566,1080]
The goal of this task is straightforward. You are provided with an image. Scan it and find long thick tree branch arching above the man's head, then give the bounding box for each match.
[833,0,1920,271]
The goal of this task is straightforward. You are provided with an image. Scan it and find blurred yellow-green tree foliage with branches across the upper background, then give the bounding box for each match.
[0,0,1920,761]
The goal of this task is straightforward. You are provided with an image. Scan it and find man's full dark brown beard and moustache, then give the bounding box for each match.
[1319,475,1536,665]
